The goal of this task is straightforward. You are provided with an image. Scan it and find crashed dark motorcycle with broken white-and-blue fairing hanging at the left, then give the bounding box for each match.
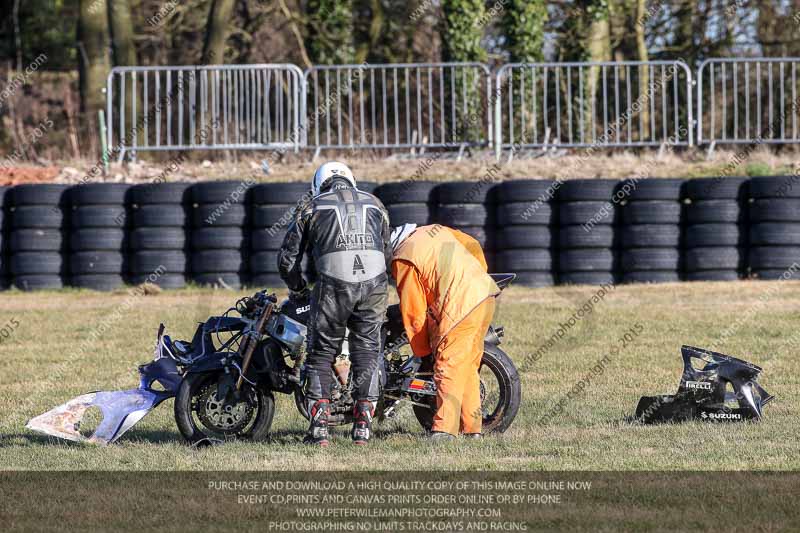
[26,274,521,444]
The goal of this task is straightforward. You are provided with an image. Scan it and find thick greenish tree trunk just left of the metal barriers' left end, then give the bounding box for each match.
[78,0,111,114]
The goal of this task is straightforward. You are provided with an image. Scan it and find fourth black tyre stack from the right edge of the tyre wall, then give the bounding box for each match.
[558,179,618,285]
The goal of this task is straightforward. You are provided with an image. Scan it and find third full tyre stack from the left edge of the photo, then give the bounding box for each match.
[130,183,195,289]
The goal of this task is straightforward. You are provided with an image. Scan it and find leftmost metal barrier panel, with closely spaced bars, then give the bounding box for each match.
[106,64,305,160]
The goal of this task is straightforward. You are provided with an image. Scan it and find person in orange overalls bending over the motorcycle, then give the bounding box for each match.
[391,224,500,440]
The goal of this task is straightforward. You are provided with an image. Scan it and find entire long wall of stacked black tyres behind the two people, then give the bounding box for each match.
[0,176,800,290]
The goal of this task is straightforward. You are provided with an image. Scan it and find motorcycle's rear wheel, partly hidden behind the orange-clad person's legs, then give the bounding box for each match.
[413,343,522,434]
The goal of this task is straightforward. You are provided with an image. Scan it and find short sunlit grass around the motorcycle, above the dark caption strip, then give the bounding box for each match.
[0,281,800,471]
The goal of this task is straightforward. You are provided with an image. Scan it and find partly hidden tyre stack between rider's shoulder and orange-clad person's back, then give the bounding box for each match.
[375,181,436,227]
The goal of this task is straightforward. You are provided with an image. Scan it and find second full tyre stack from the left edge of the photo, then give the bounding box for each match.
[68,183,130,291]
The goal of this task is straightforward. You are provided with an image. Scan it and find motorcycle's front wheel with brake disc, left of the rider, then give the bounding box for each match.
[175,372,275,444]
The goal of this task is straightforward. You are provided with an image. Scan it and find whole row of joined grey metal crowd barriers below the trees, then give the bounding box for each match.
[100,58,800,159]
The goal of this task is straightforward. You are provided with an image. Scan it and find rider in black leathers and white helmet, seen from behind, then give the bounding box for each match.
[278,162,392,446]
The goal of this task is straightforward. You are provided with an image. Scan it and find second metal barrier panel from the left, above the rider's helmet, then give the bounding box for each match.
[305,63,493,154]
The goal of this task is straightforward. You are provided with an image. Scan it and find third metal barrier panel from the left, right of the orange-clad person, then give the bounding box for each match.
[495,61,693,154]
